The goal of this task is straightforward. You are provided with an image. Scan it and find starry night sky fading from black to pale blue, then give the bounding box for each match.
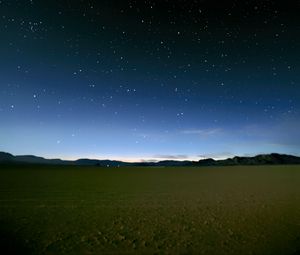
[0,0,300,161]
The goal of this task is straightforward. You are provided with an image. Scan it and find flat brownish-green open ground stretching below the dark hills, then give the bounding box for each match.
[0,166,300,254]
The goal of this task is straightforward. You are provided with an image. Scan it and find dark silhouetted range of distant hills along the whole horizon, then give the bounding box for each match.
[0,152,300,167]
